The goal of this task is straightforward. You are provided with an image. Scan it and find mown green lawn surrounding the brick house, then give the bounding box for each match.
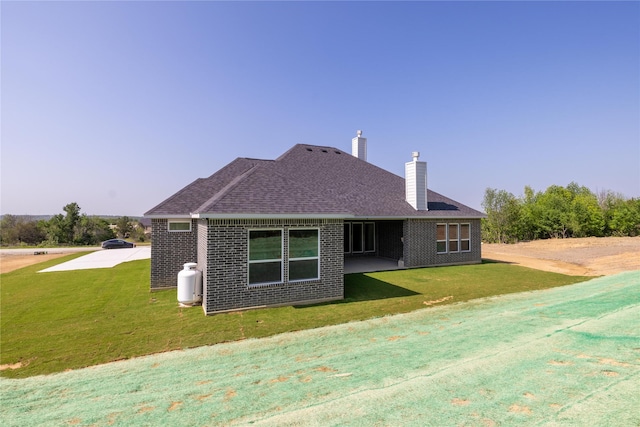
[0,254,591,378]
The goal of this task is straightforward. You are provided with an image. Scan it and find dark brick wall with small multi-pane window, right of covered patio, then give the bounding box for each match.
[403,218,482,267]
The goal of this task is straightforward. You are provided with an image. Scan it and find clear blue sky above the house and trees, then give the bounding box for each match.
[0,1,640,216]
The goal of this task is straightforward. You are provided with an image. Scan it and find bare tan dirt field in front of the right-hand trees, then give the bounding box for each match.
[482,237,640,276]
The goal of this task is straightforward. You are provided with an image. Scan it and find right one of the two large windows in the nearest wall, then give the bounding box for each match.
[289,229,320,282]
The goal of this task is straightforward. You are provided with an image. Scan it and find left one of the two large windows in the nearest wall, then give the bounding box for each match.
[249,230,282,285]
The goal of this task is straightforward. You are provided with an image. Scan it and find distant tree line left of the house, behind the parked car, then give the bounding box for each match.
[0,202,147,247]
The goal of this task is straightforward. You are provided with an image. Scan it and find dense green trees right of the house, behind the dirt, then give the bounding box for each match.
[482,182,640,243]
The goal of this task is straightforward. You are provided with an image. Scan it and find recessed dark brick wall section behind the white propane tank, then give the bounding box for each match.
[151,219,198,290]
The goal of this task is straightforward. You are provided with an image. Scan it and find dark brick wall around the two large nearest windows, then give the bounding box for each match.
[205,219,344,314]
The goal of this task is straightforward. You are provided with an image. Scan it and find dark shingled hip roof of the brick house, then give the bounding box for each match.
[145,144,484,218]
